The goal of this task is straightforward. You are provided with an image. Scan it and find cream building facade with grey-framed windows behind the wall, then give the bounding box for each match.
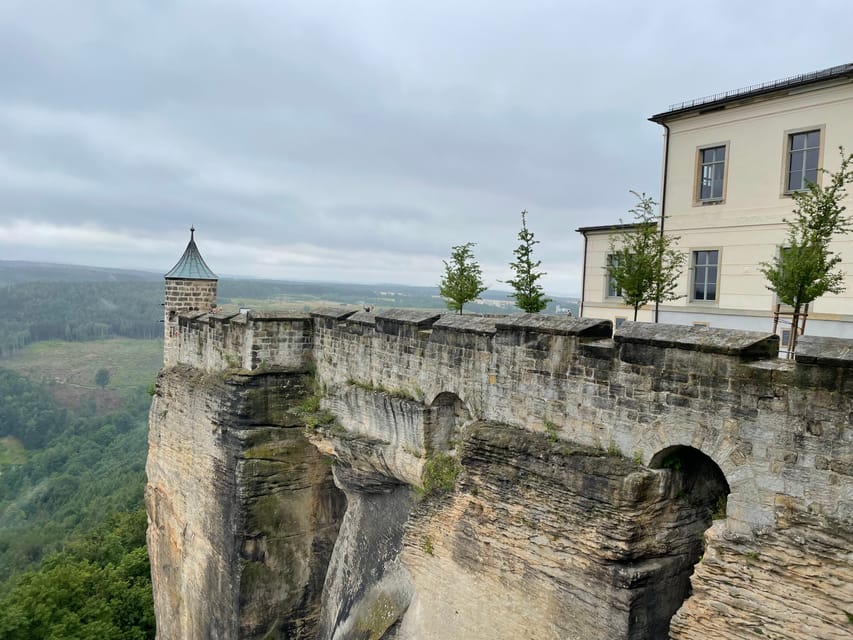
[578,64,853,343]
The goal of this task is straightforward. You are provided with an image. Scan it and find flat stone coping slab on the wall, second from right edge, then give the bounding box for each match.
[613,322,779,358]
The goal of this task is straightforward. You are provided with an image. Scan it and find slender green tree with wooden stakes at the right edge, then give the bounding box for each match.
[761,147,853,353]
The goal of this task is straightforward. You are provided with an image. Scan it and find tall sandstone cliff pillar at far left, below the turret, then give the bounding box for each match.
[146,366,344,640]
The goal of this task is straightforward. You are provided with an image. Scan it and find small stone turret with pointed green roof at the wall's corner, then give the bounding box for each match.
[163,227,218,367]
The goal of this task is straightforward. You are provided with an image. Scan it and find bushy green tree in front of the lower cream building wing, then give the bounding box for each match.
[605,191,685,321]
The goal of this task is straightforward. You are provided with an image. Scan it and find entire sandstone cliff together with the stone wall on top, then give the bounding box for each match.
[148,311,853,640]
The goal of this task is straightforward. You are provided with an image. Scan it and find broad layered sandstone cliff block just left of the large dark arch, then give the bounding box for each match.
[398,424,724,640]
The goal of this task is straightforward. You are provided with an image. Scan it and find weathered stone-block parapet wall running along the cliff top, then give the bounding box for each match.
[173,309,853,533]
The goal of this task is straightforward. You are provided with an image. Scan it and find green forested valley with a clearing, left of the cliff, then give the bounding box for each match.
[0,270,163,640]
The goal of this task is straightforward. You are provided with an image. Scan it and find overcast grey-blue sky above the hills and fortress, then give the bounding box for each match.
[0,0,853,294]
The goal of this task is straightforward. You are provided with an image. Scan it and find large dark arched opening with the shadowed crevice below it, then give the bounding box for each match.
[638,445,730,638]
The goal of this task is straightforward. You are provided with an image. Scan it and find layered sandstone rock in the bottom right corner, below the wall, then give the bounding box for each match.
[670,516,853,640]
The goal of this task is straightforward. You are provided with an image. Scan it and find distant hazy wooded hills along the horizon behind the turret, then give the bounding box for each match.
[0,261,578,324]
